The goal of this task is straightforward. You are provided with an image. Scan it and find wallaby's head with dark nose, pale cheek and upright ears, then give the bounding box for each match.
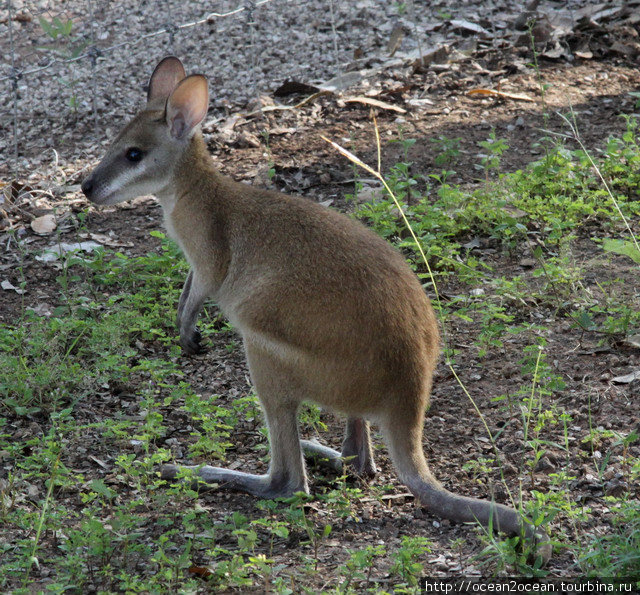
[82,56,209,205]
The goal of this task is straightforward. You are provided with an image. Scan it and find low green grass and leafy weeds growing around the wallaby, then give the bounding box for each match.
[0,118,640,593]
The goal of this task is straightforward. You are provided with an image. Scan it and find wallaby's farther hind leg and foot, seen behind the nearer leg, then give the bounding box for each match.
[300,417,376,477]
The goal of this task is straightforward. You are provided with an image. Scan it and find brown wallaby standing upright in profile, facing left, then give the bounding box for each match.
[82,56,551,562]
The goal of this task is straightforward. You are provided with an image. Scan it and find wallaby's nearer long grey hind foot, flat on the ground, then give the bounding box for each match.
[160,465,309,499]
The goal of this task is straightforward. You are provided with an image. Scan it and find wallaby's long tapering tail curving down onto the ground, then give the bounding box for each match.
[384,414,552,564]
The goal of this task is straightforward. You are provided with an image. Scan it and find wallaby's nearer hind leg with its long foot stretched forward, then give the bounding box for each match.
[161,382,309,498]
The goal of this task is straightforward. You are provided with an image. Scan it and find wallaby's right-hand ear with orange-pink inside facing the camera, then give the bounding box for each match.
[166,74,209,138]
